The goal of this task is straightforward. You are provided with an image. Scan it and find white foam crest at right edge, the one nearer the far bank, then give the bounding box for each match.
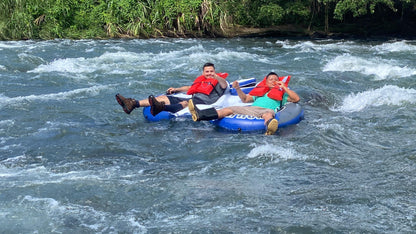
[322,54,416,80]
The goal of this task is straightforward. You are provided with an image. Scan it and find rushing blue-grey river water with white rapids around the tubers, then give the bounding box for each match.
[0,38,416,233]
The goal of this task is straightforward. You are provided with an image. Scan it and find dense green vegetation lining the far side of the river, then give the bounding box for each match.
[0,0,416,40]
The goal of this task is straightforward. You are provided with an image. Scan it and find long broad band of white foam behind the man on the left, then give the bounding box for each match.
[28,44,270,75]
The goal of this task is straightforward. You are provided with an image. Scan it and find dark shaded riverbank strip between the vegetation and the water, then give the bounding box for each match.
[4,19,416,40]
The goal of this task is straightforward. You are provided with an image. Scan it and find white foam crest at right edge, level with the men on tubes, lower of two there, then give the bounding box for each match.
[332,85,416,112]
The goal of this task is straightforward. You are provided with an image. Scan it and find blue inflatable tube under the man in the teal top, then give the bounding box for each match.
[211,103,304,132]
